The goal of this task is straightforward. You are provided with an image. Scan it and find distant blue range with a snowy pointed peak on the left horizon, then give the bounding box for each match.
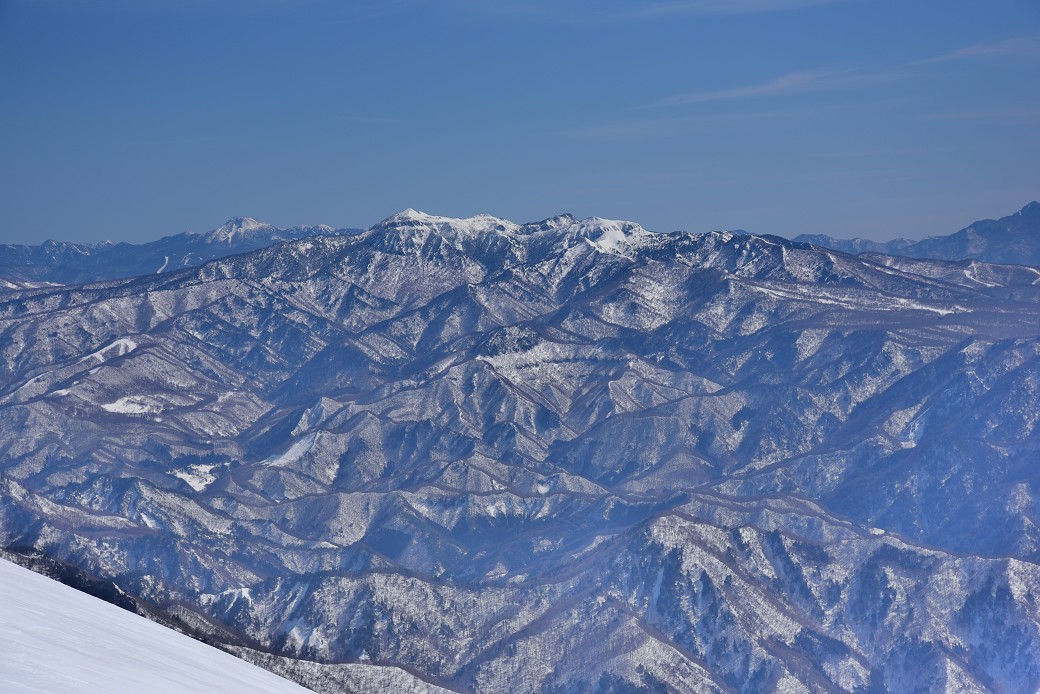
[0,216,360,289]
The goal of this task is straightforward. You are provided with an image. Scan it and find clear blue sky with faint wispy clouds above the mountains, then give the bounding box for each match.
[0,0,1040,243]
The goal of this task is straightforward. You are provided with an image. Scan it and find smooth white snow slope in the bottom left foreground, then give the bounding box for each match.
[0,560,313,694]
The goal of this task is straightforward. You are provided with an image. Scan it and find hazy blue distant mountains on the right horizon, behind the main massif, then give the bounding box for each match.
[795,202,1040,265]
